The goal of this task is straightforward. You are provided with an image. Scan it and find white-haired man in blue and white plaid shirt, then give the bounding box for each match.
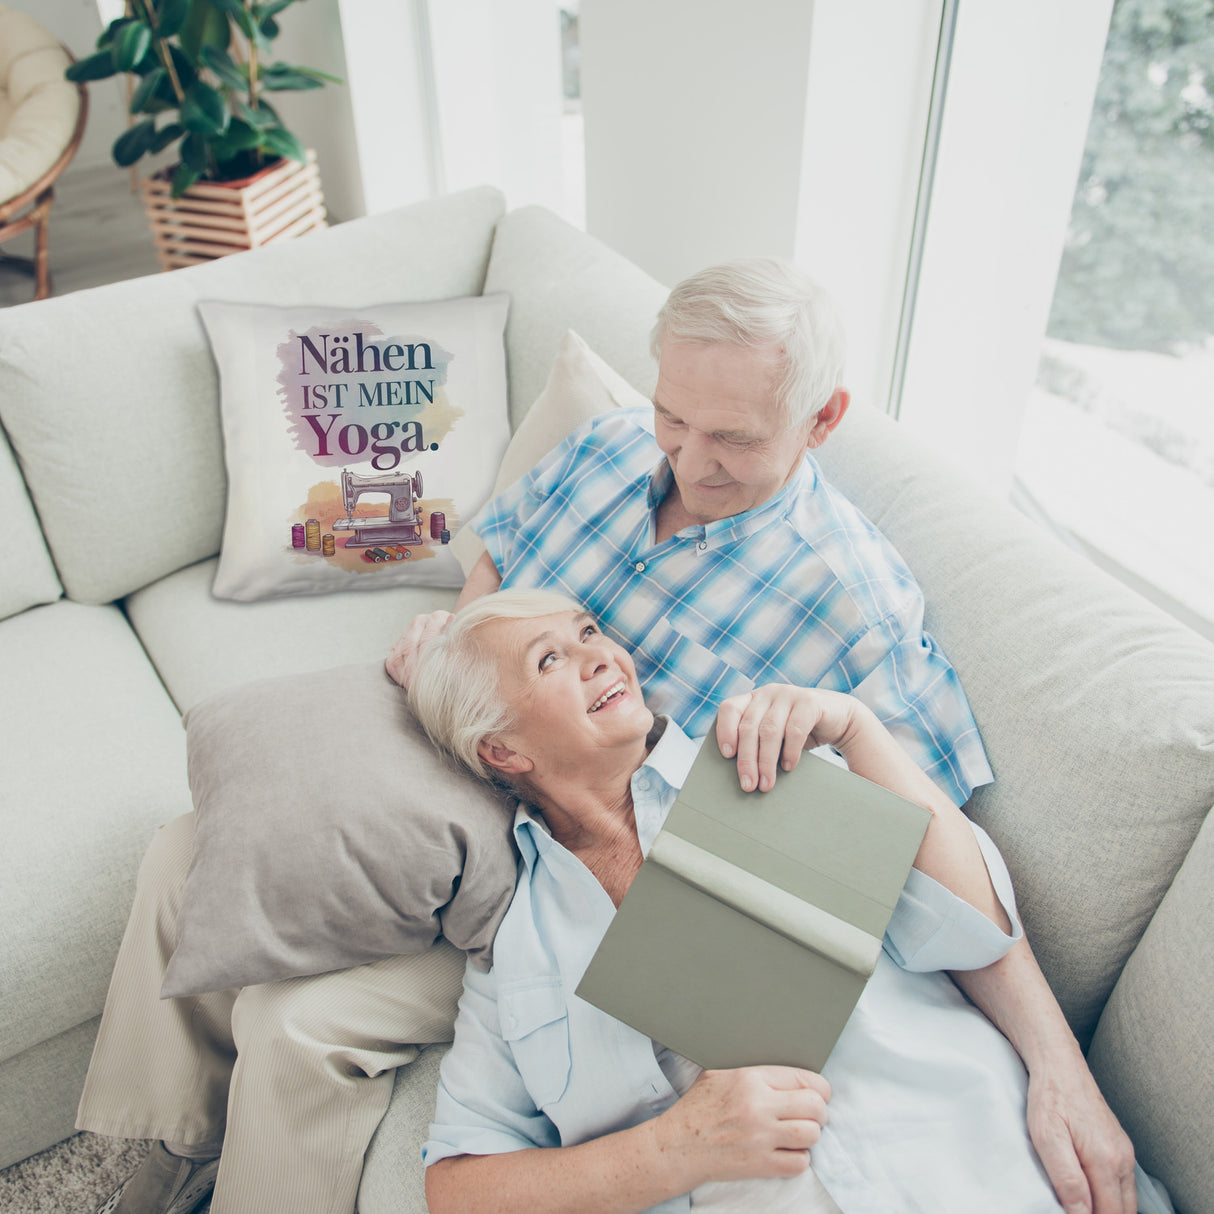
[388,261,1134,1214]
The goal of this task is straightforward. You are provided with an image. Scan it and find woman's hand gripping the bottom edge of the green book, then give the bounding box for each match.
[654,1066,830,1187]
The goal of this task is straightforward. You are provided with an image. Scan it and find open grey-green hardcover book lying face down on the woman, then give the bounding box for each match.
[577,736,931,1071]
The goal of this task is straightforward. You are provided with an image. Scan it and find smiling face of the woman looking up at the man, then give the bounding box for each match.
[477,612,653,775]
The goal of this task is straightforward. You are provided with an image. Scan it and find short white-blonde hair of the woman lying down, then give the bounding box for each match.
[409,590,583,779]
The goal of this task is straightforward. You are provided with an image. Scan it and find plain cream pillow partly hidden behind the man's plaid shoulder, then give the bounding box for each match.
[452,329,652,574]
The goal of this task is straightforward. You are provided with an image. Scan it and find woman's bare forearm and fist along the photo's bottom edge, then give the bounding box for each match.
[426,1066,830,1214]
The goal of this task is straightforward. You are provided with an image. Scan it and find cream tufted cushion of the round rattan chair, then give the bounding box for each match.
[0,6,80,200]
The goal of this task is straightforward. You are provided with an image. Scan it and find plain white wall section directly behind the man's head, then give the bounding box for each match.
[580,0,813,283]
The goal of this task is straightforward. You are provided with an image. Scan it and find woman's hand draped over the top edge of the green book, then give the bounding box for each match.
[716,683,867,793]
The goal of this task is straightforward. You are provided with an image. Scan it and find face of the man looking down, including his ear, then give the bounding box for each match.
[653,341,824,523]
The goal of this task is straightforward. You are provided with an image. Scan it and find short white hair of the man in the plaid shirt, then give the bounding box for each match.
[649,257,846,427]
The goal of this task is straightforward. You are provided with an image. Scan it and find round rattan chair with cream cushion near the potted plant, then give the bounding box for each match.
[0,5,89,300]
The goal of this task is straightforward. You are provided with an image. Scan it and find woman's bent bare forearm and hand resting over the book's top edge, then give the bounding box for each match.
[716,683,1012,934]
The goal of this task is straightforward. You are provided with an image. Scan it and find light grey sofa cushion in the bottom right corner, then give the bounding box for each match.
[1088,813,1214,1210]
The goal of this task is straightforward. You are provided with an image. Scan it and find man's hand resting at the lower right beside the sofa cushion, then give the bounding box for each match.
[1028,1059,1138,1214]
